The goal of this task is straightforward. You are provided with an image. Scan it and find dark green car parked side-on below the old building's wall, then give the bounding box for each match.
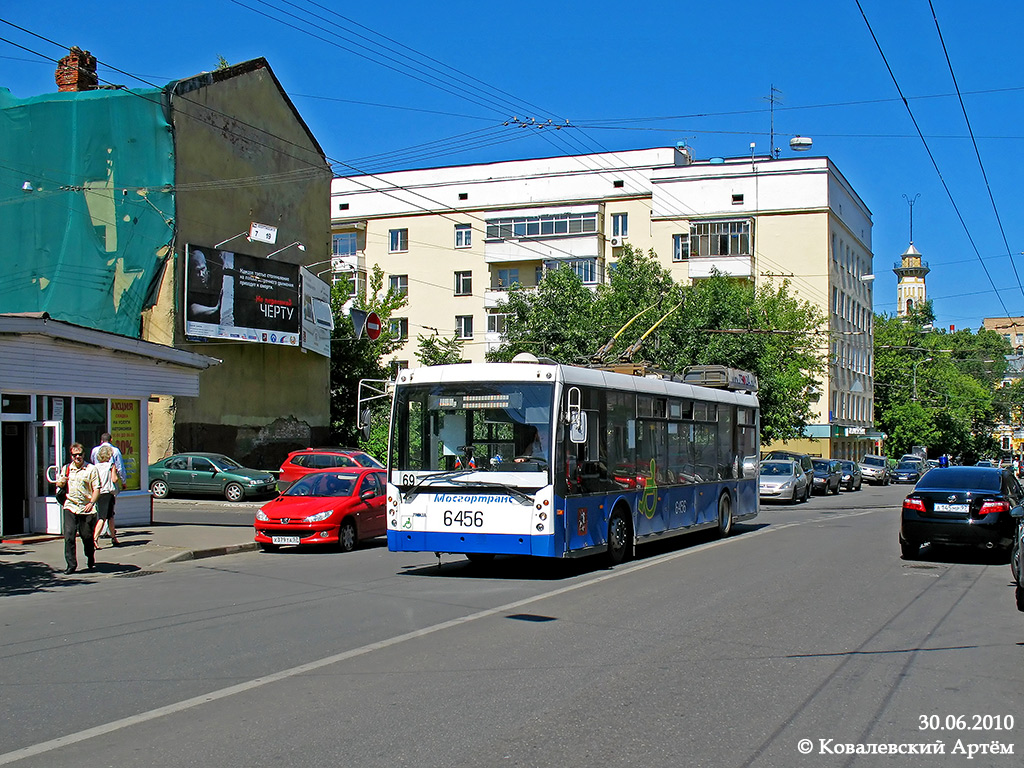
[150,453,276,502]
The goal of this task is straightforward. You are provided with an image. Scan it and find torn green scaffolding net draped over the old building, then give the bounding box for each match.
[0,88,174,338]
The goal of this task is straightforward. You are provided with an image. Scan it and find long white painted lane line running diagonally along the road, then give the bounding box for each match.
[0,507,891,765]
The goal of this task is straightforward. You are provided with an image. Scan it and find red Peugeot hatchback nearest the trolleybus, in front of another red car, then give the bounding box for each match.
[255,467,387,552]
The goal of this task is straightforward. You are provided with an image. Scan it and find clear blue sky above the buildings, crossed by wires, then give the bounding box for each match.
[0,0,1024,329]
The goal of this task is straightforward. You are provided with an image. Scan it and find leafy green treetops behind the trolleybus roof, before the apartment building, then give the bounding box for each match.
[488,246,827,442]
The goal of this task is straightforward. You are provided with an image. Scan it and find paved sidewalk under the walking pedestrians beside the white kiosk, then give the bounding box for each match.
[0,523,256,597]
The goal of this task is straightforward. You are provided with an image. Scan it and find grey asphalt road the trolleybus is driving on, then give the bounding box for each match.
[0,486,1024,768]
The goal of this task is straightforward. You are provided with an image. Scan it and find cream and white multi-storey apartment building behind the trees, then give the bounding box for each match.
[331,145,881,458]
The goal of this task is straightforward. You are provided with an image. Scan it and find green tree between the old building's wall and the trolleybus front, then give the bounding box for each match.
[331,265,408,460]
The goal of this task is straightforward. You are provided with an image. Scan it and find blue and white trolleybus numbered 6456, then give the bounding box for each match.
[387,355,759,563]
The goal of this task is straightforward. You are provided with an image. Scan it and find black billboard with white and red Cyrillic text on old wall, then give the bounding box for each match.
[184,245,302,346]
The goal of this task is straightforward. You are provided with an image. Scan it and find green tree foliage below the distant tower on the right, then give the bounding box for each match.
[874,302,1007,462]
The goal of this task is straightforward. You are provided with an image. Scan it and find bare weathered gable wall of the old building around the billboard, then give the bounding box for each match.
[143,59,331,468]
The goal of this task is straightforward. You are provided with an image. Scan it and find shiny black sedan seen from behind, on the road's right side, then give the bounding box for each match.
[899,467,1024,559]
